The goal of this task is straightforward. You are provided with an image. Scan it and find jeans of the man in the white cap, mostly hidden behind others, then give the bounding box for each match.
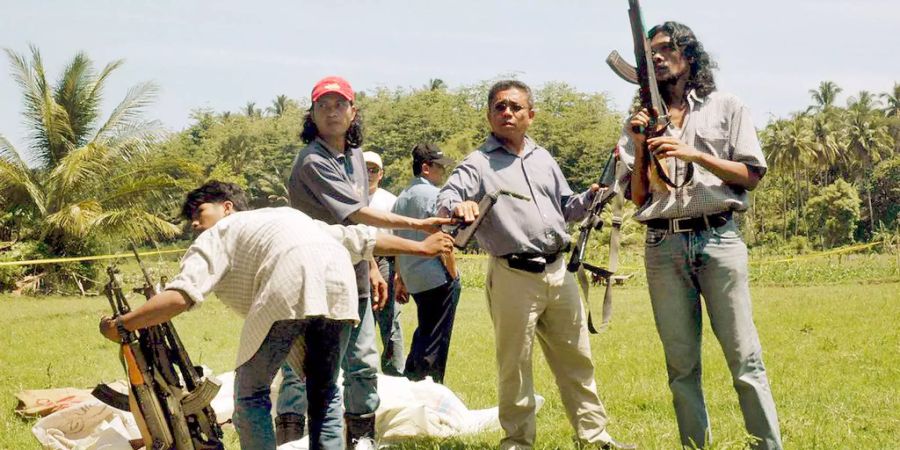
[375,257,406,377]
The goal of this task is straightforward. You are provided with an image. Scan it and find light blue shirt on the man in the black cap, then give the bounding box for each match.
[393,177,450,294]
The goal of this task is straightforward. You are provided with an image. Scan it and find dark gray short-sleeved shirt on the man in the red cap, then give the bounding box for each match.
[288,138,369,298]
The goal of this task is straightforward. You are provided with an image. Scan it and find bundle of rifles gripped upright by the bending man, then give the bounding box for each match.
[92,245,225,450]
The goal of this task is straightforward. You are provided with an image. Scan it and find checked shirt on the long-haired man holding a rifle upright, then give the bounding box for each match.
[618,91,766,222]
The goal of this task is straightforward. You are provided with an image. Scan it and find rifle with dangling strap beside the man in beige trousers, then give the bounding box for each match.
[566,151,625,334]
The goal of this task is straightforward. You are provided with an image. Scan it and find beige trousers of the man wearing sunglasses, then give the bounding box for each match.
[486,256,607,449]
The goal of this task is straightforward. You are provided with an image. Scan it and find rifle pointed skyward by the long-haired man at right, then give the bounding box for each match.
[606,0,694,192]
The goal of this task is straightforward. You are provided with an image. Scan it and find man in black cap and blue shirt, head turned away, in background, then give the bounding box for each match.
[393,143,462,383]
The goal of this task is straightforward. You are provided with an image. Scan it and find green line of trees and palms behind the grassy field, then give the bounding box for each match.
[0,47,900,288]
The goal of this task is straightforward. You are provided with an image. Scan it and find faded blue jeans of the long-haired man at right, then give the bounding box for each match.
[645,221,782,449]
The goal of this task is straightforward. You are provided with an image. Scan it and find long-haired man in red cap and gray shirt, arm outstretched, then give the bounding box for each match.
[288,76,445,448]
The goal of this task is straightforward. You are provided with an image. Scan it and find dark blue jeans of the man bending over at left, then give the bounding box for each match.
[233,317,350,450]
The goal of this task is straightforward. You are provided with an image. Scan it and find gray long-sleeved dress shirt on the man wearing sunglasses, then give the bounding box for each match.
[437,135,593,256]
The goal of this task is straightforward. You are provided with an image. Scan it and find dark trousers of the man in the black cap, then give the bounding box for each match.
[403,280,462,383]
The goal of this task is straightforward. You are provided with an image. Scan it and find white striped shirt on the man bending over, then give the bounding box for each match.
[166,207,375,367]
